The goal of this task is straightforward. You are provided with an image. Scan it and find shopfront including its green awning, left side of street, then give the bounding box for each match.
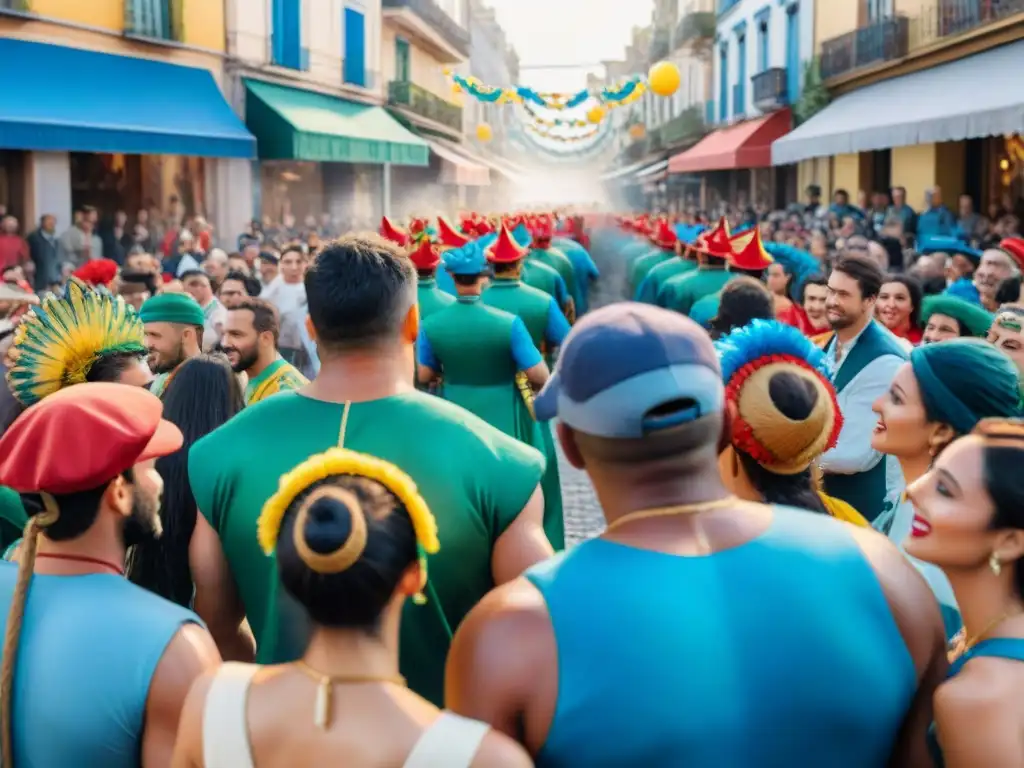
[243,78,429,227]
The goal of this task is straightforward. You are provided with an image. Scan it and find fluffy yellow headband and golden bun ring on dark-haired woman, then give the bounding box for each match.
[257,447,440,603]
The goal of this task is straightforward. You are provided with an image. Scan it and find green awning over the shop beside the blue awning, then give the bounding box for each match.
[245,80,430,166]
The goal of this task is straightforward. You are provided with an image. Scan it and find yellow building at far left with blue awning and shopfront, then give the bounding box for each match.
[0,0,255,247]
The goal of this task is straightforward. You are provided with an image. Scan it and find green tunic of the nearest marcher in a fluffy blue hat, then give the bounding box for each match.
[423,296,536,444]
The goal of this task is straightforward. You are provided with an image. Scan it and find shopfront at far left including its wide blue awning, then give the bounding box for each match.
[0,38,255,237]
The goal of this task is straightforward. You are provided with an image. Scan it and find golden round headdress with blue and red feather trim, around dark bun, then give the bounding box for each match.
[715,319,843,475]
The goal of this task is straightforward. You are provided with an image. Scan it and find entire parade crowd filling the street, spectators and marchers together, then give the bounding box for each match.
[0,187,1024,768]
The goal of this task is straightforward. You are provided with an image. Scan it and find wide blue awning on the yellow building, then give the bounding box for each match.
[0,38,256,159]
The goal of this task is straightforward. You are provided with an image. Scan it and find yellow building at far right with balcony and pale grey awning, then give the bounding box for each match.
[773,0,1024,215]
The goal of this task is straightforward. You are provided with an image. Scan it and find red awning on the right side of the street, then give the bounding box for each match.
[669,110,792,173]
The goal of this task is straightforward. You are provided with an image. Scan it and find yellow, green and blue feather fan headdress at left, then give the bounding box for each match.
[7,278,146,406]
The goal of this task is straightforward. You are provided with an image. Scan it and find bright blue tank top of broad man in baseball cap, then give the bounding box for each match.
[526,507,916,768]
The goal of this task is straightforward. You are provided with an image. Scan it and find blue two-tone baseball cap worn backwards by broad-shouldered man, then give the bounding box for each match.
[534,302,725,438]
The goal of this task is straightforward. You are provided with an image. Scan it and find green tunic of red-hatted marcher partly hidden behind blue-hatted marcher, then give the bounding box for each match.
[482,280,565,551]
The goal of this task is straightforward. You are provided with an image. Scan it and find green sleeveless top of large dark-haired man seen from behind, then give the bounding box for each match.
[188,391,544,706]
